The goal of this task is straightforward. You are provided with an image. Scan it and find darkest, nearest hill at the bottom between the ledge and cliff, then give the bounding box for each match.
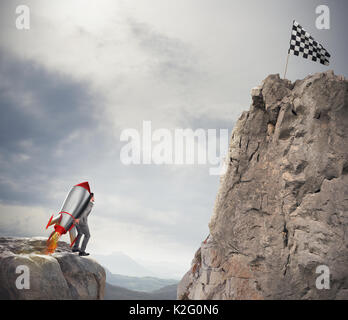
[104,283,177,300]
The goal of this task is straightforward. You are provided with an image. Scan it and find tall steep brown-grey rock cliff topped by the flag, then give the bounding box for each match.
[178,71,348,299]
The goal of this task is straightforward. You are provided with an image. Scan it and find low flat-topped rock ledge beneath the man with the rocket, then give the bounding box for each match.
[0,237,105,300]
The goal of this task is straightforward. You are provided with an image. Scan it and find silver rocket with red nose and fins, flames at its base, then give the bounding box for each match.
[46,181,92,254]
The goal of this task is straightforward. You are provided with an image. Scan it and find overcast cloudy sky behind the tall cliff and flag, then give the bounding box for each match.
[0,0,348,274]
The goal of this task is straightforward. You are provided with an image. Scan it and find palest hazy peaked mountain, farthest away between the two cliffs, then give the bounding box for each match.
[93,252,156,277]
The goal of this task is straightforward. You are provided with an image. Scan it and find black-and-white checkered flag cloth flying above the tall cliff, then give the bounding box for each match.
[289,20,331,66]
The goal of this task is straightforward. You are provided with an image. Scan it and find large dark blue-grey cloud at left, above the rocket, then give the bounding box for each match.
[0,50,106,204]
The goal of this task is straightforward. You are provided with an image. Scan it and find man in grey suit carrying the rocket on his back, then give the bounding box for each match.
[72,193,94,256]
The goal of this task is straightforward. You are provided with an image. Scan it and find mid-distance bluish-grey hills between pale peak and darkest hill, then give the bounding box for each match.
[104,268,178,292]
